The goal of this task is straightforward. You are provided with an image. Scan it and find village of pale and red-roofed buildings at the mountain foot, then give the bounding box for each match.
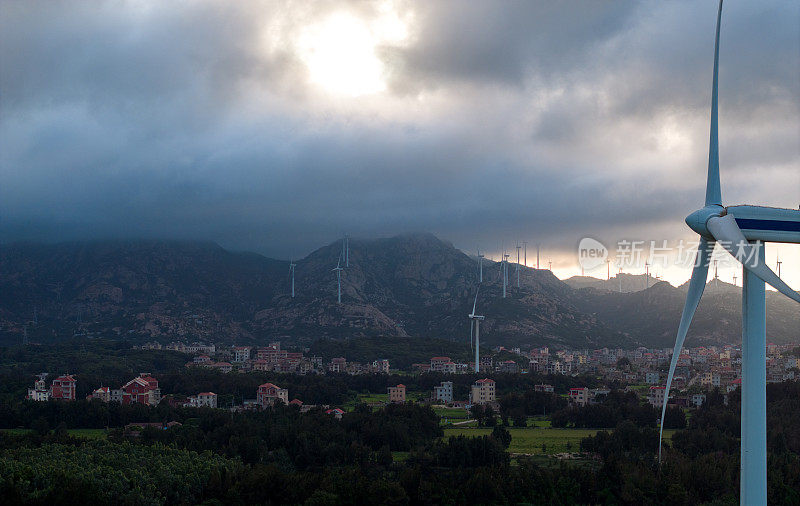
[26,342,800,417]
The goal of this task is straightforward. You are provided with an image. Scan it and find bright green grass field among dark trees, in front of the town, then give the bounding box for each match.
[444,421,675,455]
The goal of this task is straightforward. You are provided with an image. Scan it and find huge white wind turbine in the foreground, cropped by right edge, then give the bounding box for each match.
[658,0,800,505]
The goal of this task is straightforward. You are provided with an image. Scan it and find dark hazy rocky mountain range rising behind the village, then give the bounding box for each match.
[0,234,800,348]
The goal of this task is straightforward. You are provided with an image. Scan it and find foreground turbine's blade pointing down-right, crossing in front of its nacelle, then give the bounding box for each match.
[706,214,800,302]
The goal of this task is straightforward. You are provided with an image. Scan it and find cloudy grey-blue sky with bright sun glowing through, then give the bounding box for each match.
[0,0,800,288]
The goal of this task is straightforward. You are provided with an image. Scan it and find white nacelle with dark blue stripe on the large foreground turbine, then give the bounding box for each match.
[728,205,800,244]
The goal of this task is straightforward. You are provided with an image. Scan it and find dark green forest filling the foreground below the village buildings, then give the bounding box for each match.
[0,382,800,504]
